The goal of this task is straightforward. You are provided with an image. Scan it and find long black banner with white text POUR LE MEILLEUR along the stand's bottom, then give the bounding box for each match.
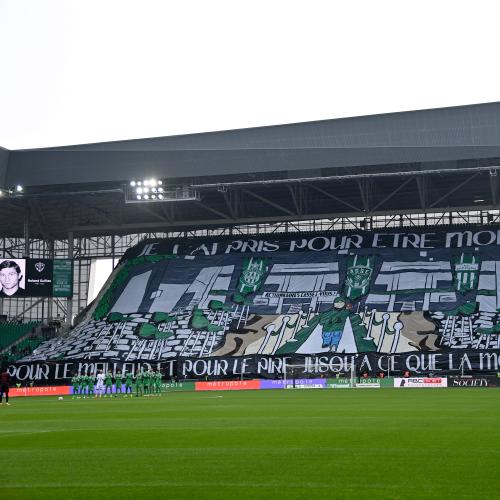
[9,350,500,385]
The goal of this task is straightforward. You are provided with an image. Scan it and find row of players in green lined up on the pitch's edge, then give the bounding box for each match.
[71,368,162,399]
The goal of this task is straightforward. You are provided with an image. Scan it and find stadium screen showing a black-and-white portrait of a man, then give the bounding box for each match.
[0,259,73,298]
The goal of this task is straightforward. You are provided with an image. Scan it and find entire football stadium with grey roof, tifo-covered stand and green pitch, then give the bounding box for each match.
[0,103,500,499]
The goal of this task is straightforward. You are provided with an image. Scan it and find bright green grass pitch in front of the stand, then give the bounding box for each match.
[0,389,500,500]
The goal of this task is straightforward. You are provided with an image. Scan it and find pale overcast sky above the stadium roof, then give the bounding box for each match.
[0,0,500,149]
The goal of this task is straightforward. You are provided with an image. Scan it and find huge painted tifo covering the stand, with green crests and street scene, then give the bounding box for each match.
[10,226,500,376]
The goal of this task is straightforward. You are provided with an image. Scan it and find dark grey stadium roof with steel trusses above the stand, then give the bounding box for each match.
[0,103,500,238]
